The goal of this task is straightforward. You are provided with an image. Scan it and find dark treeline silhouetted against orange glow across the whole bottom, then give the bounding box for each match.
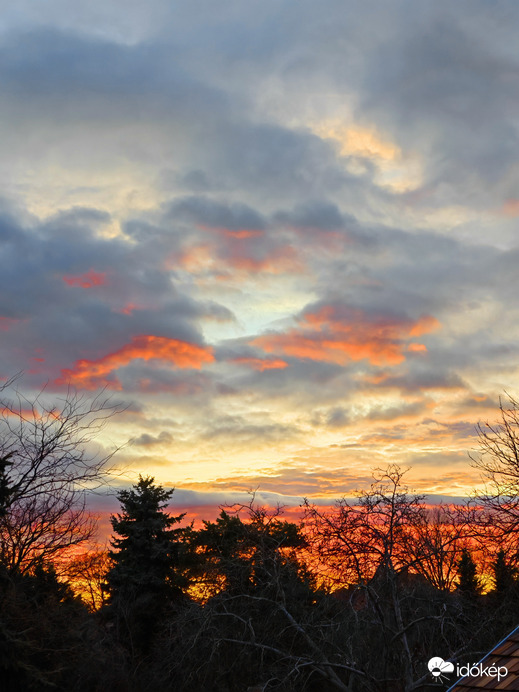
[0,386,519,692]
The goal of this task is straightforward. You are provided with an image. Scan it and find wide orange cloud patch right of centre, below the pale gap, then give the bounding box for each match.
[252,305,440,366]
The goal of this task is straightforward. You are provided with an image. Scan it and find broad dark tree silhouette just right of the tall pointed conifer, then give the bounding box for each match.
[160,497,363,692]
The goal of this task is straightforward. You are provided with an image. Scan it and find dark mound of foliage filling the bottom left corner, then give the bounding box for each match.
[0,563,132,692]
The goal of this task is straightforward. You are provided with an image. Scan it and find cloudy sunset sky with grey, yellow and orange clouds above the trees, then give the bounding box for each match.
[0,0,519,507]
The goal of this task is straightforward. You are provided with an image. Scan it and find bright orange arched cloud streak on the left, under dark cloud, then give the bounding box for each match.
[55,334,214,389]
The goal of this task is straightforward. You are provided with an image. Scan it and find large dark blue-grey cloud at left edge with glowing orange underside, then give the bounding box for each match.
[0,203,234,388]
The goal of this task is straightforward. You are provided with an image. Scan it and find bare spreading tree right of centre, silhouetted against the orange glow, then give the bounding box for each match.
[304,465,474,692]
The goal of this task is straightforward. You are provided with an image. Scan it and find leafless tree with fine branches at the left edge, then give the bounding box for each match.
[0,388,120,572]
